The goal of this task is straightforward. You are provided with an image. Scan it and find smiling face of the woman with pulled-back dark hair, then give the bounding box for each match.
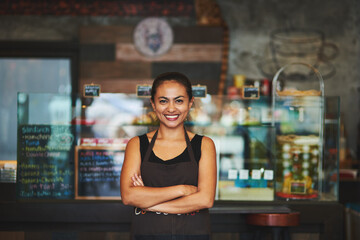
[151,81,193,128]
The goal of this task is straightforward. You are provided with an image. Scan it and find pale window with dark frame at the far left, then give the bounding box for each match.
[0,42,77,161]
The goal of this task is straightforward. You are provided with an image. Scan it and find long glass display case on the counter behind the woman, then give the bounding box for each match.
[17,93,339,201]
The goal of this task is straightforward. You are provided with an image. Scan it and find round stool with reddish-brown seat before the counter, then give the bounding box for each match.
[246,212,300,240]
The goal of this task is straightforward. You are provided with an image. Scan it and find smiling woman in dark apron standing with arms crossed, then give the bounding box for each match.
[121,72,216,240]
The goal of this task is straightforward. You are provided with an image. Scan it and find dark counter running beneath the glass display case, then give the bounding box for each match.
[0,188,344,240]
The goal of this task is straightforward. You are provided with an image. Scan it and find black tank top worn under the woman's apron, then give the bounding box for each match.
[139,134,203,165]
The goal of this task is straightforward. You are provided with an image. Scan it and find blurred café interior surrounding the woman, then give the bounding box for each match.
[0,0,360,240]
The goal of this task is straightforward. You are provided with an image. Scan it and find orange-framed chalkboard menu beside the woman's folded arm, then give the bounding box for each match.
[75,146,124,199]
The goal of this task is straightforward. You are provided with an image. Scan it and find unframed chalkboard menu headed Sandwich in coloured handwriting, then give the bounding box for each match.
[16,125,75,199]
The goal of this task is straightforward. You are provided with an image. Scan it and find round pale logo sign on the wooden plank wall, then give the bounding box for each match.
[134,17,174,57]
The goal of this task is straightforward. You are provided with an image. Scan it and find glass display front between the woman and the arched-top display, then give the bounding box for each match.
[189,96,274,201]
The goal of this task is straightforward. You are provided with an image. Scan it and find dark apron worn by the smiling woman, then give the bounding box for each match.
[131,130,210,240]
